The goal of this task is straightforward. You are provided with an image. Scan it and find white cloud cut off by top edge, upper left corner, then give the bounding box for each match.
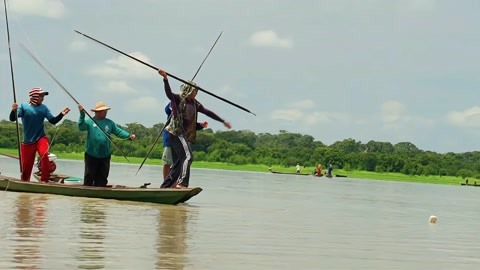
[9,0,66,19]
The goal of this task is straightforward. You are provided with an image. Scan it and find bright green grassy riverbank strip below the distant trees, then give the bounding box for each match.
[0,148,468,185]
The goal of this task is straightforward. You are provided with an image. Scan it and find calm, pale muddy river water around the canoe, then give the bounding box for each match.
[0,157,480,269]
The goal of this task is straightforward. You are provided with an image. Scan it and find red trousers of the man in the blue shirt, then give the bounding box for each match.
[20,137,50,182]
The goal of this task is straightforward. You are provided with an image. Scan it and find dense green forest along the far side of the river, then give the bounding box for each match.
[0,119,480,178]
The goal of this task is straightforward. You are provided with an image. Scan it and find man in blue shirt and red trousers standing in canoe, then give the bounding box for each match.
[9,87,70,183]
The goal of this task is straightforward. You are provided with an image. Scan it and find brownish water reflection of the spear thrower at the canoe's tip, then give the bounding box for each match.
[156,205,191,270]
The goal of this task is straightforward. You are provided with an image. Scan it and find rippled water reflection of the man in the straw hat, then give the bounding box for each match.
[75,200,106,269]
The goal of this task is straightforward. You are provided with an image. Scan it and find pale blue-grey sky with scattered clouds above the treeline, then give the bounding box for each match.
[0,0,480,153]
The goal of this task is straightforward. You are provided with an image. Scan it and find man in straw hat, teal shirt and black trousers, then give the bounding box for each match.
[78,102,135,187]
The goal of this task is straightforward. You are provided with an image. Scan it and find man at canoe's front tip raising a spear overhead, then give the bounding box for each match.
[158,69,231,188]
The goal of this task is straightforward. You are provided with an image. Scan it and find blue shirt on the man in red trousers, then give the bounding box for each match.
[17,102,55,144]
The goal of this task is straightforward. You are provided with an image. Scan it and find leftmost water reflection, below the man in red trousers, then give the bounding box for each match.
[13,194,47,269]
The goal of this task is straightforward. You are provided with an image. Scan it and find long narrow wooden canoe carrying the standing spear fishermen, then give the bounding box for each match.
[0,175,202,204]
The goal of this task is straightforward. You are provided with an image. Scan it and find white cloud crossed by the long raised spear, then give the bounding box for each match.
[89,52,156,79]
